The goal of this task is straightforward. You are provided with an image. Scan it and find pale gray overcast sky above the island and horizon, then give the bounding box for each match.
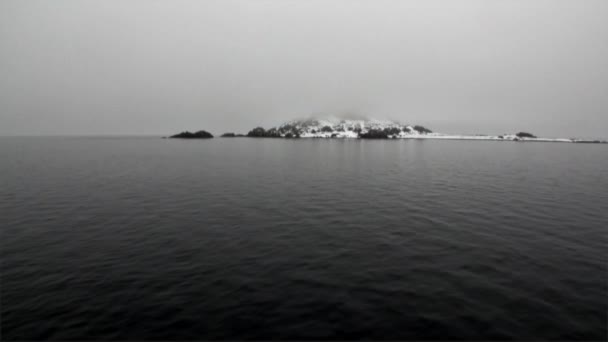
[0,0,608,138]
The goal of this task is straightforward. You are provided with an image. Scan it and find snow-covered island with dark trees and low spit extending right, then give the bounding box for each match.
[240,117,607,143]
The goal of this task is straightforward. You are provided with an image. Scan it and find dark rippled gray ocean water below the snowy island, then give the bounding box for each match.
[0,137,608,340]
